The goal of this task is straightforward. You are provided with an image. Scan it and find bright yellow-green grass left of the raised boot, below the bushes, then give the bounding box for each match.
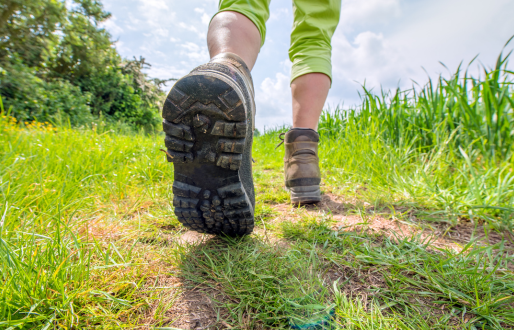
[0,111,172,329]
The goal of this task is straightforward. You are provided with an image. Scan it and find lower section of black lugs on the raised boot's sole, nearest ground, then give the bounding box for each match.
[173,181,254,236]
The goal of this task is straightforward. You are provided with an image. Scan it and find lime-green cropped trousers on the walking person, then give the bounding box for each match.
[219,0,341,81]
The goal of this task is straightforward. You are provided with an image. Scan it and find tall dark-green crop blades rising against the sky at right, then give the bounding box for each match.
[319,46,514,161]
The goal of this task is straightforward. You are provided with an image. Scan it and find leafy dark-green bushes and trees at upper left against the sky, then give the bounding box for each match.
[0,0,164,128]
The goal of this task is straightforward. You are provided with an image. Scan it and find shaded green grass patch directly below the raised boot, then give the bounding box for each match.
[181,237,331,328]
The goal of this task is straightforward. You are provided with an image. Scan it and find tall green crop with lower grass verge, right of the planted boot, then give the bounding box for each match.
[312,49,514,227]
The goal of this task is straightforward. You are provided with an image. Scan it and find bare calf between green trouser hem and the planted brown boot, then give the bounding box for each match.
[291,73,330,130]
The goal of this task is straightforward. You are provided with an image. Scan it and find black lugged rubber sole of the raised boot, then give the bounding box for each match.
[162,76,254,236]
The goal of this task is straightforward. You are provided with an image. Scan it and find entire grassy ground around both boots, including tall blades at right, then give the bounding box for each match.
[0,52,514,329]
